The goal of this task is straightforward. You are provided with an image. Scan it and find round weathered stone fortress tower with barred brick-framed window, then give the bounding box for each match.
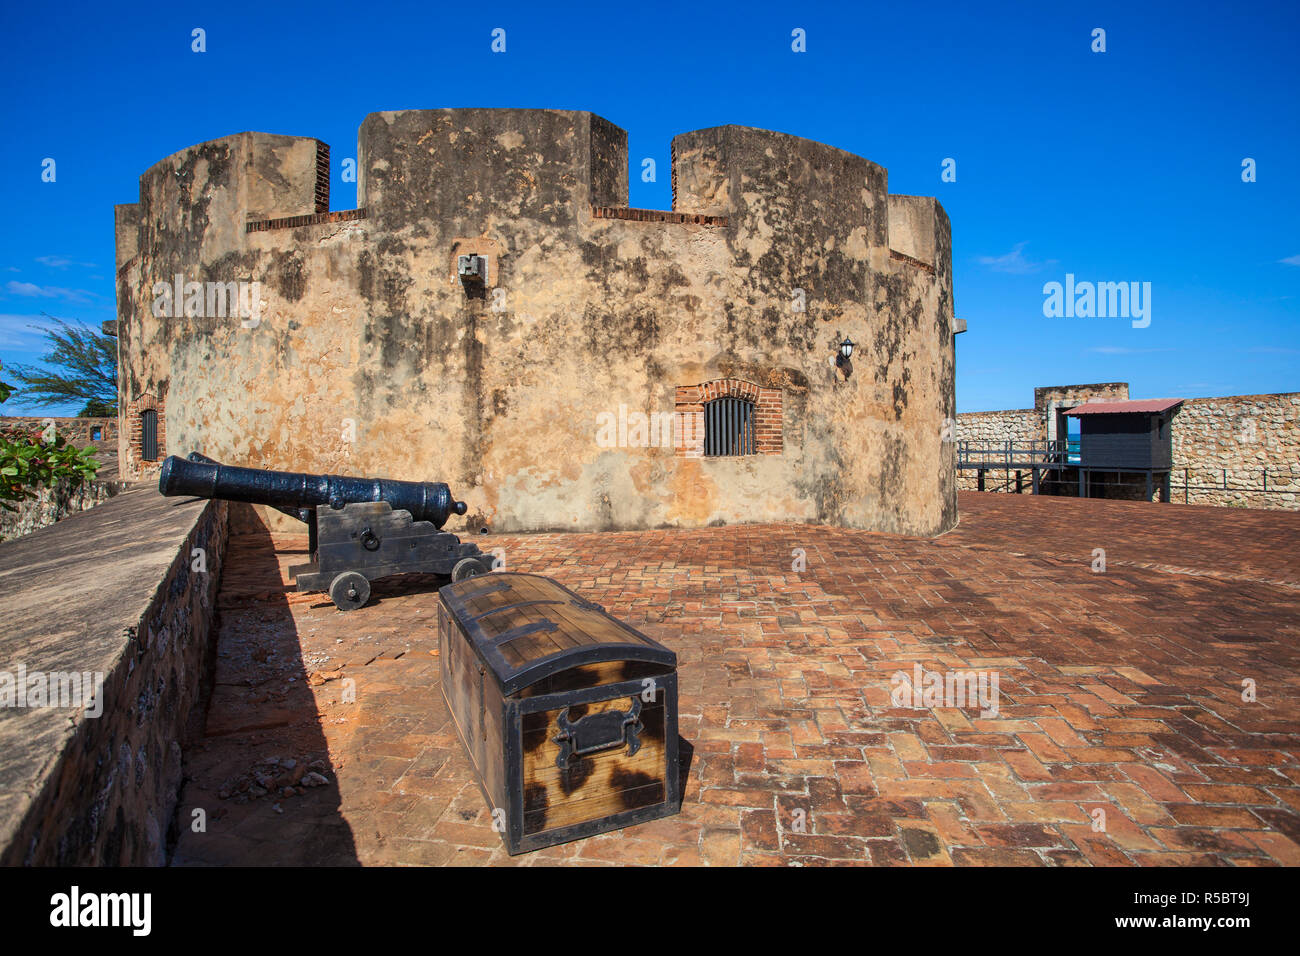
[116,109,961,535]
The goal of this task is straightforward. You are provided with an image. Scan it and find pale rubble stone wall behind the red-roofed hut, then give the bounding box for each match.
[956,392,1300,511]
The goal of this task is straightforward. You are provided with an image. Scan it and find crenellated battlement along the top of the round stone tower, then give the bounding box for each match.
[116,108,949,273]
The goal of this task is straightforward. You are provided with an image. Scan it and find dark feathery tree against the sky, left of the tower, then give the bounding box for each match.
[0,312,117,418]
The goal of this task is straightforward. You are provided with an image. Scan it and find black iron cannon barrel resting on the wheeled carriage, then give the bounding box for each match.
[159,451,467,528]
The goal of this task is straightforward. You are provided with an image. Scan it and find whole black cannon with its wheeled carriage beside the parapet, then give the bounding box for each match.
[159,451,493,611]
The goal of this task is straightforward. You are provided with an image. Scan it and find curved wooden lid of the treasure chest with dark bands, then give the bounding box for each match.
[438,571,677,695]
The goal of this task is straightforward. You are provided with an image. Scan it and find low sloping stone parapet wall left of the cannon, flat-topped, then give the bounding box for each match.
[0,488,228,866]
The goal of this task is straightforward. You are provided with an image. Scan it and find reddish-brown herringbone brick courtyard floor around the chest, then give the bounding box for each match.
[174,492,1300,865]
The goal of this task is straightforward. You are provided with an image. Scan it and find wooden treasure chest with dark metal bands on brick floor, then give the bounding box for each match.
[438,572,681,853]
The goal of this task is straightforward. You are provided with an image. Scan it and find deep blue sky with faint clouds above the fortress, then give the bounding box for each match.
[0,3,1300,414]
